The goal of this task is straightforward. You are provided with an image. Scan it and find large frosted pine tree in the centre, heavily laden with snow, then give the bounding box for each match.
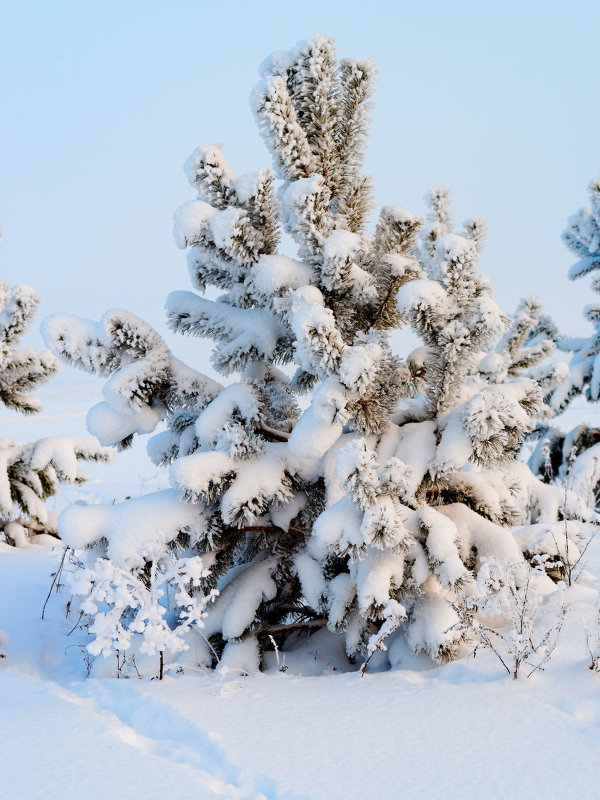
[45,37,592,669]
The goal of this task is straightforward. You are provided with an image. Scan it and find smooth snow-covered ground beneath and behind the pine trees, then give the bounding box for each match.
[0,385,600,800]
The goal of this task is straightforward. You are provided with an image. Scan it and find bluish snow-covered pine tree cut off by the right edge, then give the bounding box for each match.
[529,178,600,507]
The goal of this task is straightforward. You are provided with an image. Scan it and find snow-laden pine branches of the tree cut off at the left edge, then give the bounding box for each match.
[0,256,111,545]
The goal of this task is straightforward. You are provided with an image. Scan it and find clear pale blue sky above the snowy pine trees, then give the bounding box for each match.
[0,0,600,382]
